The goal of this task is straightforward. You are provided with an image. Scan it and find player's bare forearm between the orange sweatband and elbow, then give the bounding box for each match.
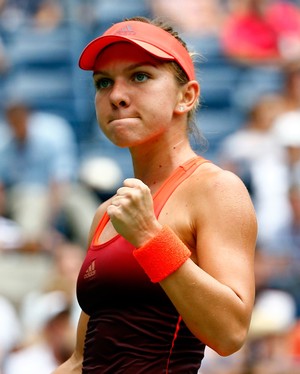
[160,259,254,356]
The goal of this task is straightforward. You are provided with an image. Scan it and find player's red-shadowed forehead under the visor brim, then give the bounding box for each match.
[94,42,162,71]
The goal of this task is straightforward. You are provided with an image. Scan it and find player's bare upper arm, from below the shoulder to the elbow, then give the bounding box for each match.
[196,171,257,306]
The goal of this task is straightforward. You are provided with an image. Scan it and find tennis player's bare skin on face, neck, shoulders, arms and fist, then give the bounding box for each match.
[54,43,257,374]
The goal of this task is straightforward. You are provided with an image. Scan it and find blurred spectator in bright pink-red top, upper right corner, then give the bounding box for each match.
[221,0,300,64]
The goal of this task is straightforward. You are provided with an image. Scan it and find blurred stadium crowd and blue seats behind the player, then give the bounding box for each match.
[0,0,300,374]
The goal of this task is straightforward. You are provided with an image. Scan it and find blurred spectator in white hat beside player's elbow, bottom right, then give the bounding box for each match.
[247,289,300,374]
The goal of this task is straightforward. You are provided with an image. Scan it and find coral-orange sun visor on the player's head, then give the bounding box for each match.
[79,21,195,80]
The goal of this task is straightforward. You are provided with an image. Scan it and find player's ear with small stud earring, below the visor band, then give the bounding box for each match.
[174,80,200,114]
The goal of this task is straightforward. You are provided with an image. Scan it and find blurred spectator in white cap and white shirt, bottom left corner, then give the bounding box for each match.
[3,291,74,374]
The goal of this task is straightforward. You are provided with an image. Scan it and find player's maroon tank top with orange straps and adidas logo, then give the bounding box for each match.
[77,157,207,374]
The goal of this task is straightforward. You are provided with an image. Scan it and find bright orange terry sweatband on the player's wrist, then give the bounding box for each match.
[133,226,191,283]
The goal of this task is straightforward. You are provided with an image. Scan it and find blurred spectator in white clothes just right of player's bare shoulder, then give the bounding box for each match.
[218,95,289,245]
